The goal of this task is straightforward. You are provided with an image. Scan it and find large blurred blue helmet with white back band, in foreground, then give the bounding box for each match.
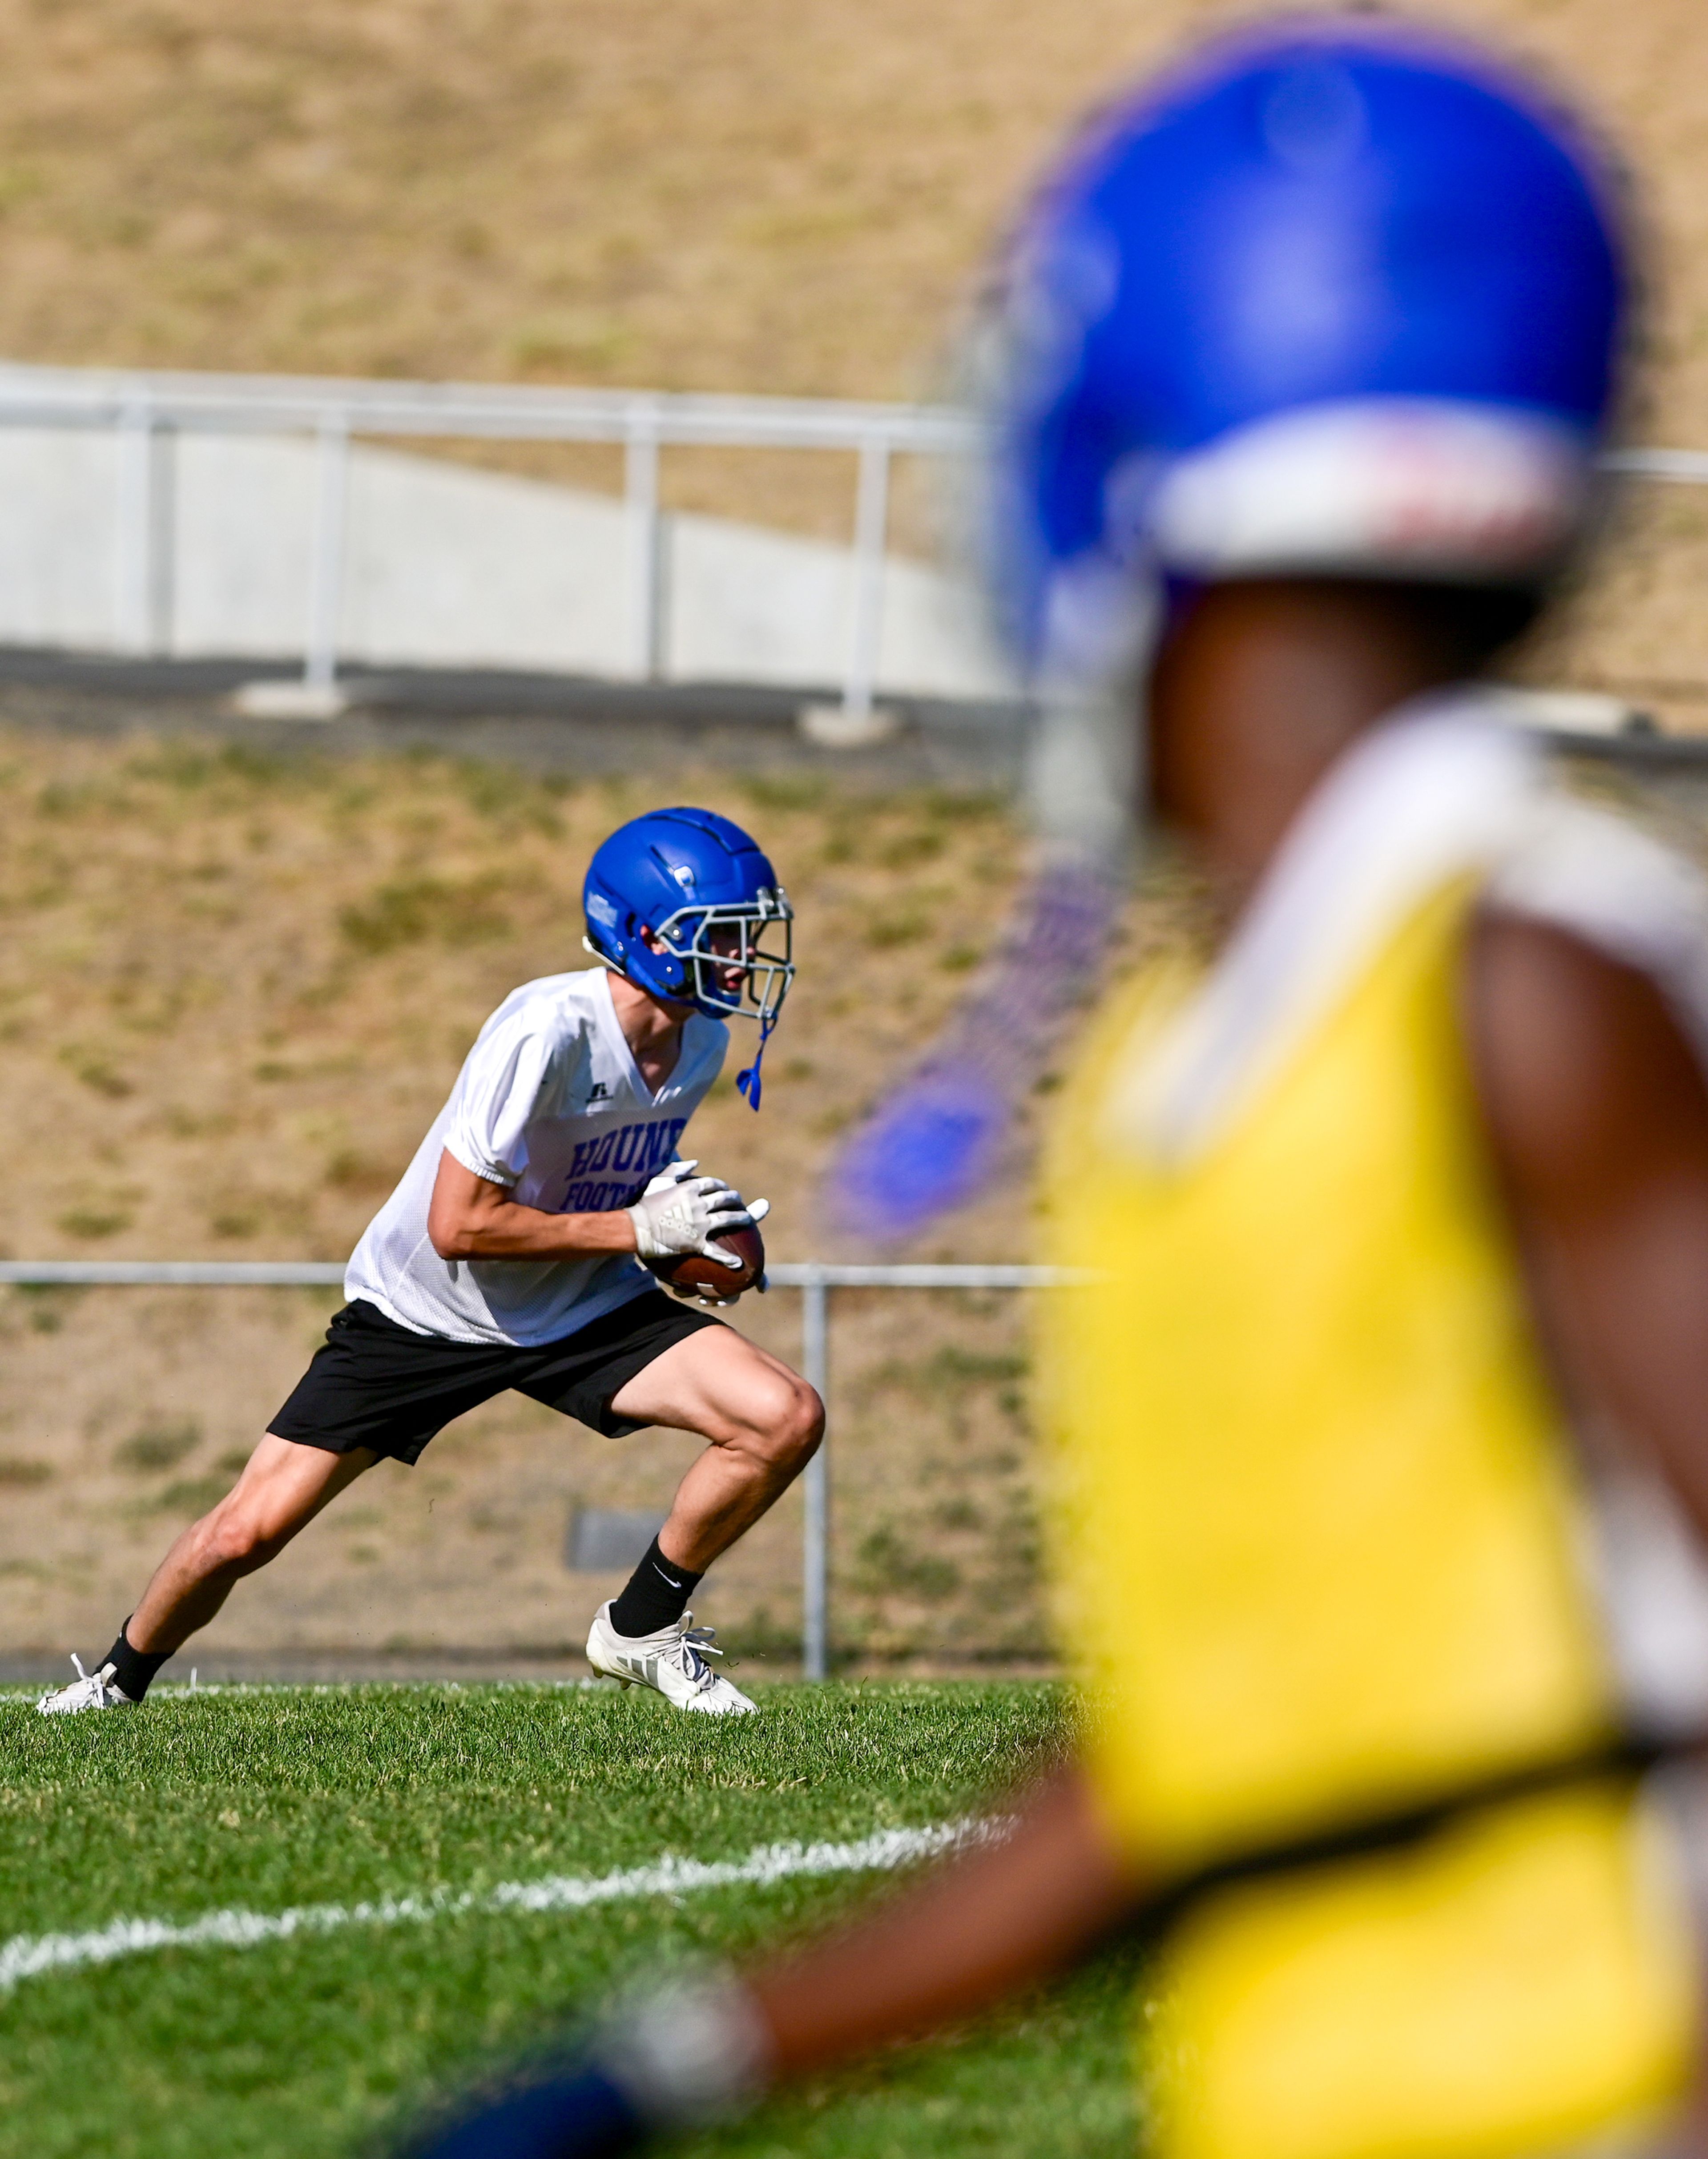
[991,17,1630,685]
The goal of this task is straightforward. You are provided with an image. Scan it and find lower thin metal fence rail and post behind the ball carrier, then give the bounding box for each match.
[0,1259,1082,1680]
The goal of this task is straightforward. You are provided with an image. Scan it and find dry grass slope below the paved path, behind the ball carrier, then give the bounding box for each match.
[0,730,1175,1669]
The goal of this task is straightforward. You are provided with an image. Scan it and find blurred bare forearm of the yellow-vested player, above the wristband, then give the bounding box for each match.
[749,1770,1140,2077]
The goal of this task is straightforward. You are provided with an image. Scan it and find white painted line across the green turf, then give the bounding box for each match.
[0,1820,1002,1993]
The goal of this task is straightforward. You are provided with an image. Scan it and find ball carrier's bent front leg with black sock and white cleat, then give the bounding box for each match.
[587,1328,825,1716]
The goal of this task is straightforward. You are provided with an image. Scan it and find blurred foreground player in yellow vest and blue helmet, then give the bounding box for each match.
[403,22,1708,2159]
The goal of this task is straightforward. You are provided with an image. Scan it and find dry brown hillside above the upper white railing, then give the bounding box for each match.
[0,0,1708,548]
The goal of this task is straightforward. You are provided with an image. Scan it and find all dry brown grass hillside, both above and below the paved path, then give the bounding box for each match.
[0,0,1708,1660]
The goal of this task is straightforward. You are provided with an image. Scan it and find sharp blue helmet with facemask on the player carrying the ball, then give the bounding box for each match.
[581,810,794,1110]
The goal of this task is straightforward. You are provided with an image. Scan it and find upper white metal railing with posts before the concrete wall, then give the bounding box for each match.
[0,367,983,715]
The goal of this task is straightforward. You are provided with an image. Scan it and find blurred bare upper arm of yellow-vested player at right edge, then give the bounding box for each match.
[1468,913,1708,1537]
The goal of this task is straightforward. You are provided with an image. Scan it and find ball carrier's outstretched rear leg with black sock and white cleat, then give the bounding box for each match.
[41,1431,380,1714]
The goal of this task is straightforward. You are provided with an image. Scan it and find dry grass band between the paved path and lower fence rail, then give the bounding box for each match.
[0,734,1040,1257]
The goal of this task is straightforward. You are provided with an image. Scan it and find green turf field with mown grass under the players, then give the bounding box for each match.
[0,1684,1132,2159]
